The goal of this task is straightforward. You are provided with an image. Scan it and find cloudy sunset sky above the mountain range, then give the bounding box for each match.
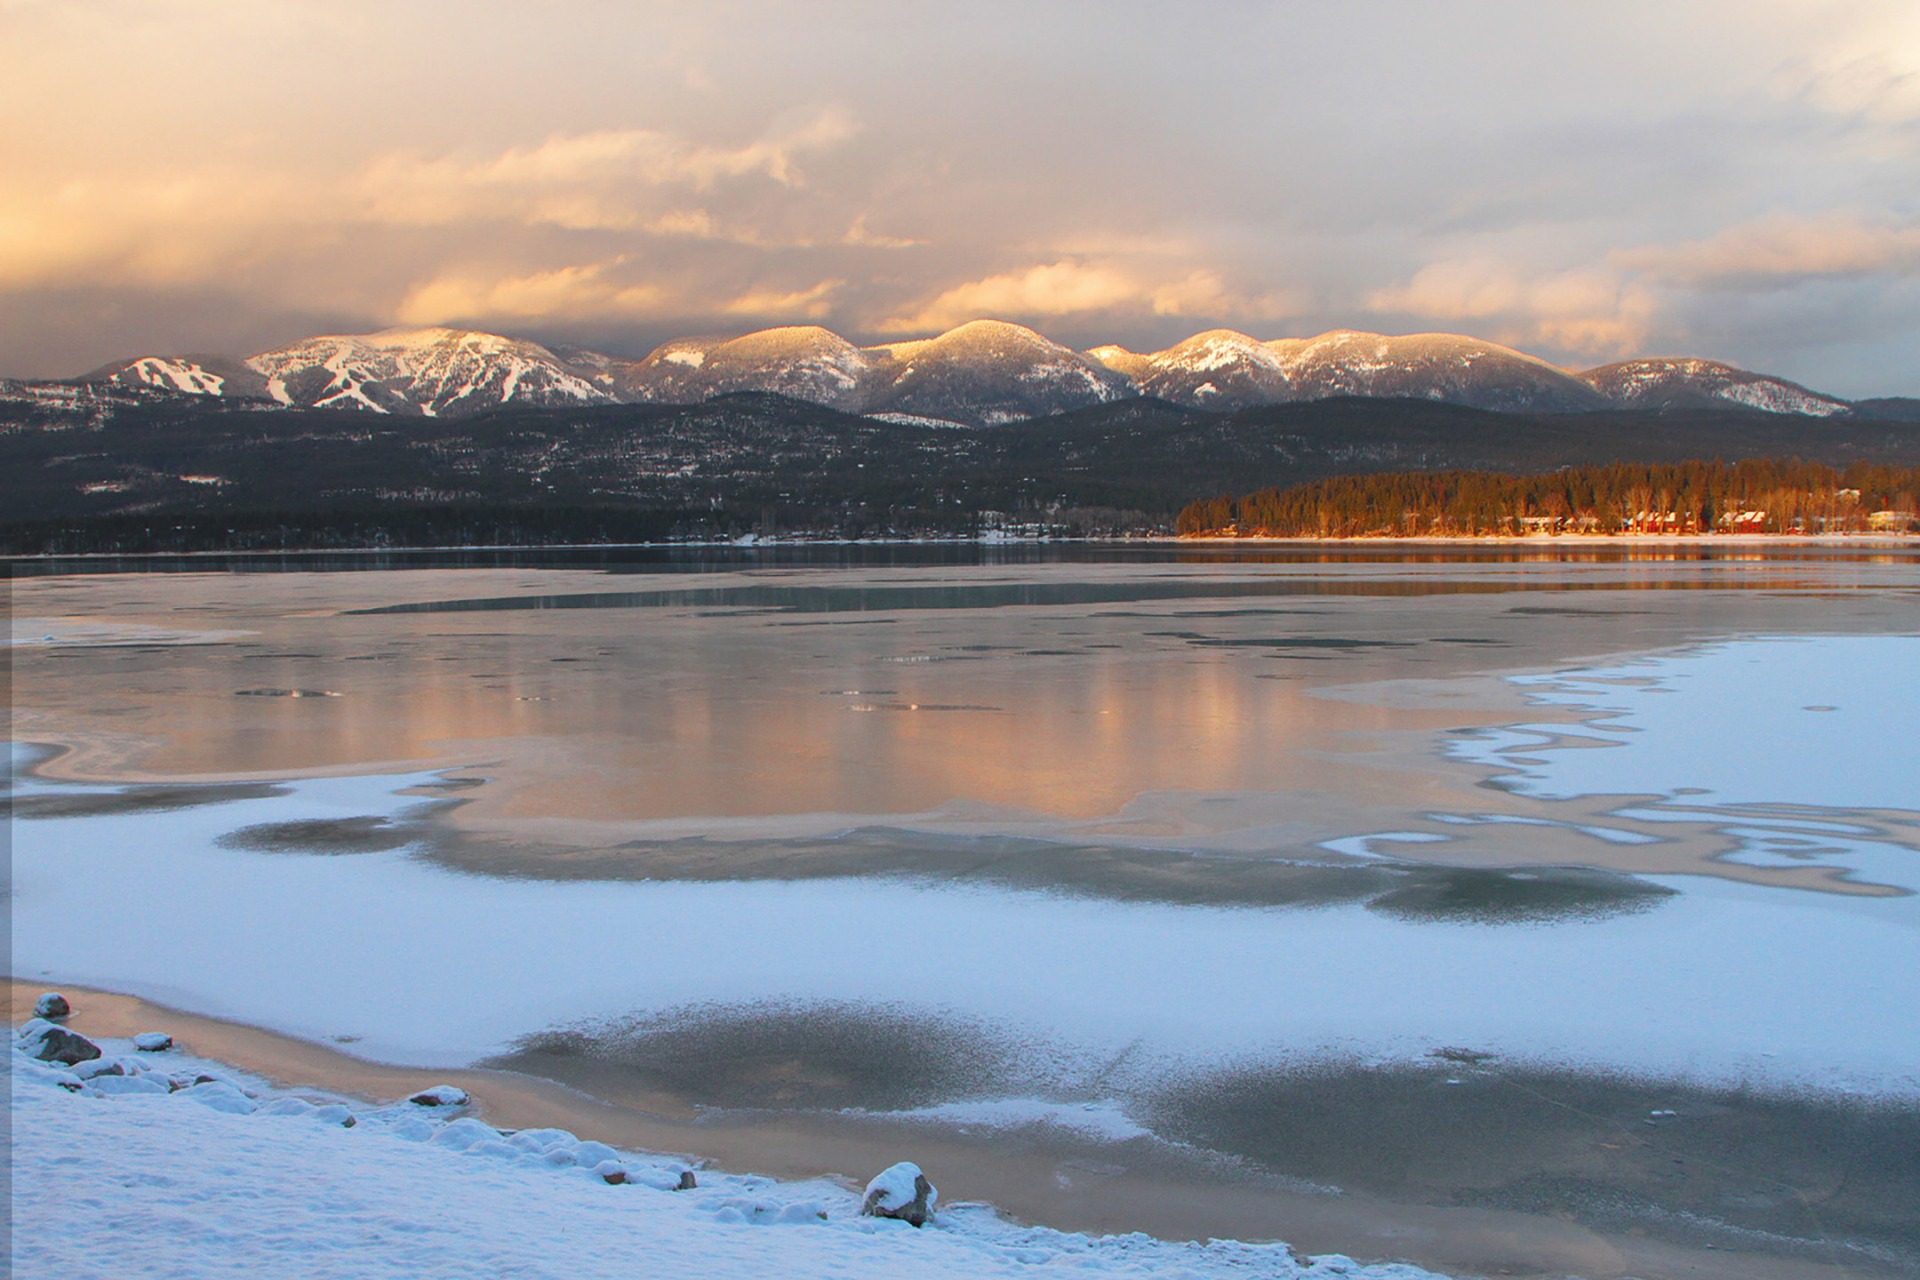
[0,0,1920,395]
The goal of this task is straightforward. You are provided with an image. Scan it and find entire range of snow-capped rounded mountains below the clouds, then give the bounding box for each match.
[83,320,1881,426]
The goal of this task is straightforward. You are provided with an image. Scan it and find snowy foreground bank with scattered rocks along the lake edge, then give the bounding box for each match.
[10,1040,1432,1280]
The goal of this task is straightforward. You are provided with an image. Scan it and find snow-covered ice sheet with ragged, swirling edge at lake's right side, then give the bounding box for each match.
[1453,635,1920,890]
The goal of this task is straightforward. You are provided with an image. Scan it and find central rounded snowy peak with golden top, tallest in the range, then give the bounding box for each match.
[864,320,1135,426]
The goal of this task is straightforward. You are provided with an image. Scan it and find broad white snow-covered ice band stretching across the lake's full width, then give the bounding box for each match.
[12,759,1920,1102]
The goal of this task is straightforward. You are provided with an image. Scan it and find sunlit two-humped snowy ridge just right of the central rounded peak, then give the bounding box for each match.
[1091,328,1605,413]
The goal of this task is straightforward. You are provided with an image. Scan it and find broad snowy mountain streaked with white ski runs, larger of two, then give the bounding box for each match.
[248,328,618,416]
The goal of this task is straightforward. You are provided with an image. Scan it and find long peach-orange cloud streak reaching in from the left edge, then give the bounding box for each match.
[0,109,854,297]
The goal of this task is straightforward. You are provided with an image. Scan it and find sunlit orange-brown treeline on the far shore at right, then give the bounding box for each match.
[1175,459,1920,537]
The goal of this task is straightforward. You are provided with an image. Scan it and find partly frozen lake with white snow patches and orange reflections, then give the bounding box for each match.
[10,551,1920,1274]
